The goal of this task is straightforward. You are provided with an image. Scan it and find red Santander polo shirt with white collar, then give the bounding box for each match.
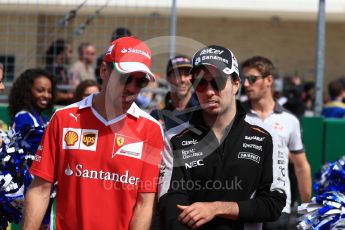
[30,95,163,230]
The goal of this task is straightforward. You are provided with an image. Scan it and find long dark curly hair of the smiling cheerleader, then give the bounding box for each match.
[8,68,55,118]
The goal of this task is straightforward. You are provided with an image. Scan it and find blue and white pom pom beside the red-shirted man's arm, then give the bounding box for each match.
[0,127,45,230]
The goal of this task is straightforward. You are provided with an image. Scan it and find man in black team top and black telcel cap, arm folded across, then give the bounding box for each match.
[158,46,286,229]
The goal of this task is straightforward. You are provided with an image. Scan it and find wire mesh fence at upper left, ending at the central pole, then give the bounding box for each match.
[0,0,171,93]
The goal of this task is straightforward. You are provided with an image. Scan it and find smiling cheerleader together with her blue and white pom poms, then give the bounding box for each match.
[0,69,55,229]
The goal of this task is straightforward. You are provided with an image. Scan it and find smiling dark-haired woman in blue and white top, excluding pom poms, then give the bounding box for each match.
[9,69,55,152]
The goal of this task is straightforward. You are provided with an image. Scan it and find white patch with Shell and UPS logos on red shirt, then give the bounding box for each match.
[62,128,98,151]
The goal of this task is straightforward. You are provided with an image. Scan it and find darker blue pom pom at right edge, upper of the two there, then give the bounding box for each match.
[313,156,345,194]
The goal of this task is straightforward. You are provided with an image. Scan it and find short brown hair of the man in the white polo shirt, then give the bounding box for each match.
[241,56,276,77]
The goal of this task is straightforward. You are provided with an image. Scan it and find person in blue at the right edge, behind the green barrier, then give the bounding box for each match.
[322,79,345,118]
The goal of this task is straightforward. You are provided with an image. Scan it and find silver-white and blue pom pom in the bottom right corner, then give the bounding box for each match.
[297,191,345,230]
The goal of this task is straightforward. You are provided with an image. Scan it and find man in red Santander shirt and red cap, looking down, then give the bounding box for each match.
[23,37,163,230]
